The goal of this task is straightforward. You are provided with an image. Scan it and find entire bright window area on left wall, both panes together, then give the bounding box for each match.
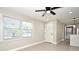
[3,17,32,39]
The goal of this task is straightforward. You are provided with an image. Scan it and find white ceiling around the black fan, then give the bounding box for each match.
[0,7,79,24]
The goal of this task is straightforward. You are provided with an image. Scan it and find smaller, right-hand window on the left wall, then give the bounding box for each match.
[22,22,32,37]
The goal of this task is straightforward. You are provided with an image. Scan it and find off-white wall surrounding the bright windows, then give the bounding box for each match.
[0,10,44,50]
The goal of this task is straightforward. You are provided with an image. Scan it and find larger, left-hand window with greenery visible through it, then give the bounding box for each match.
[3,17,21,39]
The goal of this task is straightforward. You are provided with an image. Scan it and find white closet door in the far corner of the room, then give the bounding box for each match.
[45,22,53,42]
